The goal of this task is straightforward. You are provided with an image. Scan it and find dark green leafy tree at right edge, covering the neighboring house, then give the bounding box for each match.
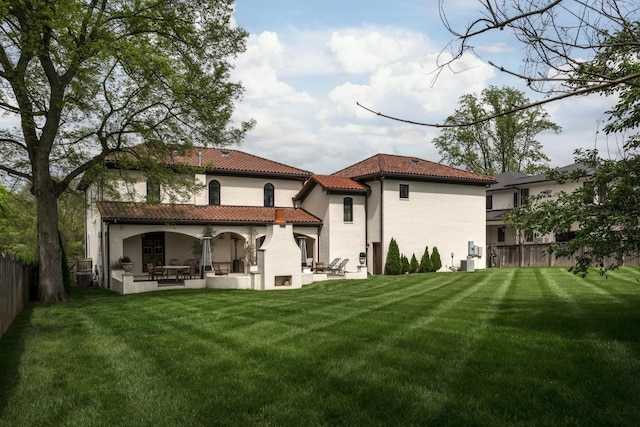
[506,8,640,276]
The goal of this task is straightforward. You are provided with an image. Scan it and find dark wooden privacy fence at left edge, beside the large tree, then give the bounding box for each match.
[0,255,30,337]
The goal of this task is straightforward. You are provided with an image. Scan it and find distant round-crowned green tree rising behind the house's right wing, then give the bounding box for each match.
[433,86,560,175]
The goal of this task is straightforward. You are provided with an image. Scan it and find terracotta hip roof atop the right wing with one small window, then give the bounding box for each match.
[333,154,495,184]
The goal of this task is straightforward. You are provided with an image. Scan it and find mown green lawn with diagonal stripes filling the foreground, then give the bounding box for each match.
[0,268,640,427]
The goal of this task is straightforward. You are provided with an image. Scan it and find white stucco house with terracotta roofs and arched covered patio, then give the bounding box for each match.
[84,148,494,294]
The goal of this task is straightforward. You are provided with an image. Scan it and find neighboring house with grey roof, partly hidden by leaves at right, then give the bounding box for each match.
[486,163,586,246]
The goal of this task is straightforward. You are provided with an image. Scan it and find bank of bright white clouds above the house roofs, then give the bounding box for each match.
[234,19,602,173]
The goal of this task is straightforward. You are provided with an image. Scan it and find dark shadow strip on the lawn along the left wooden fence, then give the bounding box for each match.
[0,303,35,420]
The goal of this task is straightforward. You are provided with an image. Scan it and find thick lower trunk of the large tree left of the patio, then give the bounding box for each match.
[34,168,69,302]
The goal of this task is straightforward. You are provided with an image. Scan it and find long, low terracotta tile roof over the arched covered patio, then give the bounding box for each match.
[97,202,322,225]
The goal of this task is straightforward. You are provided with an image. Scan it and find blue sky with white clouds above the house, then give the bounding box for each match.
[233,0,615,174]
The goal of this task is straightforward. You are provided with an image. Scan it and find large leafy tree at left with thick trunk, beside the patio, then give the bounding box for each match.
[0,0,253,302]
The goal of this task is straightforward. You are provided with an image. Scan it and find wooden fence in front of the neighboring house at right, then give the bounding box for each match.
[487,243,640,268]
